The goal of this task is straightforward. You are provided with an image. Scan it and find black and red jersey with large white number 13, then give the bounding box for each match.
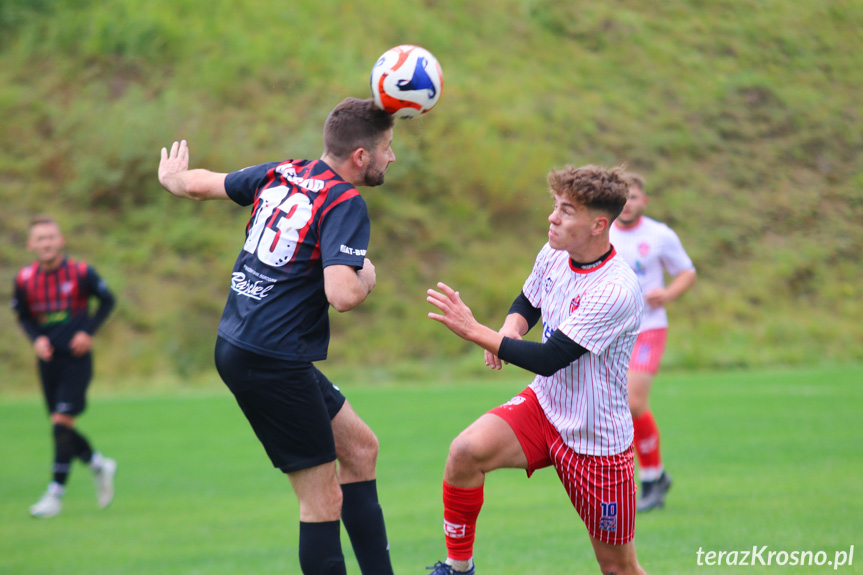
[219,160,371,361]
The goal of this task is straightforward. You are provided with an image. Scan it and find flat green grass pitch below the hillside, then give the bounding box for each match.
[0,365,863,575]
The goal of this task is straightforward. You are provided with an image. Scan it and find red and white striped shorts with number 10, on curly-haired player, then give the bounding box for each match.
[489,388,636,545]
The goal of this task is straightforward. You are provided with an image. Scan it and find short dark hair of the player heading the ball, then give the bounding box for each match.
[324,98,395,160]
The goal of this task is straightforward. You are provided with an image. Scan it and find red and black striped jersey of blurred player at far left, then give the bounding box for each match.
[12,257,114,354]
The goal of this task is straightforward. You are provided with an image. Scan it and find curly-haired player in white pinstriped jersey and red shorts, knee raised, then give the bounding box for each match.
[428,166,644,575]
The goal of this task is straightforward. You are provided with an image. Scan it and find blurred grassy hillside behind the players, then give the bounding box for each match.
[0,0,863,390]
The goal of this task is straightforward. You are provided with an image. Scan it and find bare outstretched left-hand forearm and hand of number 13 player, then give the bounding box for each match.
[159,140,228,201]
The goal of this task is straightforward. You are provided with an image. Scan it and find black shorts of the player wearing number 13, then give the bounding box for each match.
[216,337,345,473]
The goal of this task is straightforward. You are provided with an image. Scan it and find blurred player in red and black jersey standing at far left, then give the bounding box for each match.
[12,216,117,517]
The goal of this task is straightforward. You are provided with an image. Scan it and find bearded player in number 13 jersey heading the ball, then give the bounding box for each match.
[159,98,395,575]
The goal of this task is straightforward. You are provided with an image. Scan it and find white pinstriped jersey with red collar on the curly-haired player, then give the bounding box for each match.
[523,244,644,455]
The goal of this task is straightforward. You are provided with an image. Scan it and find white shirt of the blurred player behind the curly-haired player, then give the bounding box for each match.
[609,216,695,331]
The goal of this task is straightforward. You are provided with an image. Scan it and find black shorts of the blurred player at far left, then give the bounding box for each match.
[39,353,93,415]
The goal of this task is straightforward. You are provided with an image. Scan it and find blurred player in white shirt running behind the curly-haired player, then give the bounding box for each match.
[610,173,695,511]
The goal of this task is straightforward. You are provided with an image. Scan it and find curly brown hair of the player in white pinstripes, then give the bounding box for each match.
[548,165,629,220]
